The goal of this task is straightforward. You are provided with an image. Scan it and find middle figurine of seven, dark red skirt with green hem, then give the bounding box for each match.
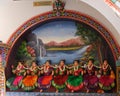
[52,60,68,92]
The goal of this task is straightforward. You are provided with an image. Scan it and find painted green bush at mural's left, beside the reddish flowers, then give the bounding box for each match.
[16,41,31,61]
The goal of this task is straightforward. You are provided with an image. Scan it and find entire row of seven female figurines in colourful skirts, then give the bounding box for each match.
[6,59,115,93]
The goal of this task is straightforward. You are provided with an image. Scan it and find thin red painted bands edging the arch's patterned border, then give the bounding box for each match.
[6,10,120,66]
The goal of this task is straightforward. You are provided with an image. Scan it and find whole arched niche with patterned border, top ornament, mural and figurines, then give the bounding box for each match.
[5,0,120,95]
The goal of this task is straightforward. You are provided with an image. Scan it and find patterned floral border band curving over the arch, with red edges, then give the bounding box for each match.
[7,10,120,60]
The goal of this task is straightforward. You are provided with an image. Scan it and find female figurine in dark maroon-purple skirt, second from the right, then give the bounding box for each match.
[84,59,98,93]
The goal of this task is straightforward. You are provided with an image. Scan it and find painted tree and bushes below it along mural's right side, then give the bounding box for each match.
[75,23,102,64]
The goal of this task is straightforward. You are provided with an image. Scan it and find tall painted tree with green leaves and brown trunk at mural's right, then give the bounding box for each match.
[76,23,102,63]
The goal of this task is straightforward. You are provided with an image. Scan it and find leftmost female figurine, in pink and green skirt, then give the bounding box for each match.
[6,62,25,90]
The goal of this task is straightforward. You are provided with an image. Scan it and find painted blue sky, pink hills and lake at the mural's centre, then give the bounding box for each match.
[33,21,88,64]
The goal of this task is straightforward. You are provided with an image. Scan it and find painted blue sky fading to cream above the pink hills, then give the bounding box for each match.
[33,21,77,43]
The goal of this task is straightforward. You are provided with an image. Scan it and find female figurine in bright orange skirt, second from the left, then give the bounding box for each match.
[22,61,38,91]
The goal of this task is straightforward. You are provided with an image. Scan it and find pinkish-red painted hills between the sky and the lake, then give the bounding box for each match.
[45,37,84,47]
